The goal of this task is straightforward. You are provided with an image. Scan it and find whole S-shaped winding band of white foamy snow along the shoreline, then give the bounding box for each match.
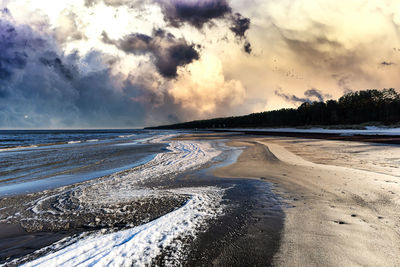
[8,135,228,266]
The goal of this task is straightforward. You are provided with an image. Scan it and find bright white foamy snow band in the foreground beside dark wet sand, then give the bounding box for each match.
[23,187,224,266]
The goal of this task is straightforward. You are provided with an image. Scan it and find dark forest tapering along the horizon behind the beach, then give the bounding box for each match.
[150,88,400,129]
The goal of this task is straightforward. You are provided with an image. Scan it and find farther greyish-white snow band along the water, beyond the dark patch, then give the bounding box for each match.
[7,135,221,221]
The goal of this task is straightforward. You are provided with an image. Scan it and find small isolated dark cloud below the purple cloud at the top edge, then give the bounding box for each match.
[103,30,199,78]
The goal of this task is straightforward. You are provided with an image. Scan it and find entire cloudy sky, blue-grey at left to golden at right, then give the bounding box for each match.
[0,0,400,128]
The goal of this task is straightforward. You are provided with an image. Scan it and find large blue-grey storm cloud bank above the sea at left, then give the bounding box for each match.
[0,15,146,128]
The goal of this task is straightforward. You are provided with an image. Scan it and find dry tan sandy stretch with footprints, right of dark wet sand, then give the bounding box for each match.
[214,137,400,266]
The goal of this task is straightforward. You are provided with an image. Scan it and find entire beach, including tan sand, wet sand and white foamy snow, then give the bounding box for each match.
[0,132,400,266]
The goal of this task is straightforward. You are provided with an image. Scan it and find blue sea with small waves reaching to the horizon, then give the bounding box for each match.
[0,129,169,197]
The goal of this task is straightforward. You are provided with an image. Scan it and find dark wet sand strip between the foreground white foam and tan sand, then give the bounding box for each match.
[170,171,284,267]
